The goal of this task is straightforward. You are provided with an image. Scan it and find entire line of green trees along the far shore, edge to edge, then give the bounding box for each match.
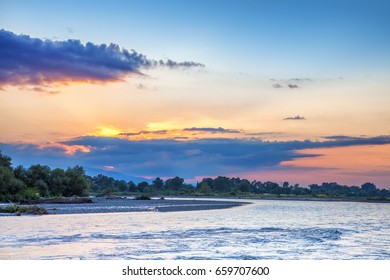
[0,152,390,201]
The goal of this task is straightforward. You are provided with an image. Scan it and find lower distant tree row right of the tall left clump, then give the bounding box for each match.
[88,174,390,199]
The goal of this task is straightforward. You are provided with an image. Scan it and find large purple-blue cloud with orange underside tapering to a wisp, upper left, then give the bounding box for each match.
[0,29,204,87]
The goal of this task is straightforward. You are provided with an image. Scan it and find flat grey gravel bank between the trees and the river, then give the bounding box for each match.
[0,195,390,216]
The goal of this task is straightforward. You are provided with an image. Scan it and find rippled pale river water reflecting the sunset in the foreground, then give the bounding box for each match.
[0,200,390,259]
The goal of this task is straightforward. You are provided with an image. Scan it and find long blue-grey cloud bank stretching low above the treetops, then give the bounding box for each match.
[0,136,390,178]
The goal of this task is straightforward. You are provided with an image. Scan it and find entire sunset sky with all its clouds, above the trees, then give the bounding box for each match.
[0,0,390,188]
